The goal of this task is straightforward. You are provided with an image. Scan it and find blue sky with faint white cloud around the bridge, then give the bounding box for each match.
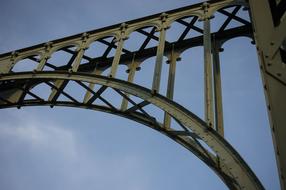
[0,0,279,190]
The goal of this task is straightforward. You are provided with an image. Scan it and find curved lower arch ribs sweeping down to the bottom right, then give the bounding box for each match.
[0,71,264,190]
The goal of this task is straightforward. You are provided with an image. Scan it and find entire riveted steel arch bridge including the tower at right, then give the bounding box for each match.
[0,0,286,190]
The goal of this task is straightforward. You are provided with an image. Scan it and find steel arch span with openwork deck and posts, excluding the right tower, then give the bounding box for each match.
[0,0,270,189]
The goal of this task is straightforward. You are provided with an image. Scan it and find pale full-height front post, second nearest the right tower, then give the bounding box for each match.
[152,13,167,92]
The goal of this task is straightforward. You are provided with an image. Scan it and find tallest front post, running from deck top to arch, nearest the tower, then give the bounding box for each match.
[203,3,214,127]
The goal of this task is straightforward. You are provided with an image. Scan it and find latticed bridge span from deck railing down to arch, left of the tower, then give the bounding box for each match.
[0,0,263,189]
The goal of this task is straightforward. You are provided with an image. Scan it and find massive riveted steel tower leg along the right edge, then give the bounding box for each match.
[249,0,286,190]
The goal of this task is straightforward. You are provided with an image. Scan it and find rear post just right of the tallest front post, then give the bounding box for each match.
[212,39,224,136]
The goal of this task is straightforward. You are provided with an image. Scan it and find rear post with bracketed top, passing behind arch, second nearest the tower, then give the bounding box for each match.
[164,45,179,128]
